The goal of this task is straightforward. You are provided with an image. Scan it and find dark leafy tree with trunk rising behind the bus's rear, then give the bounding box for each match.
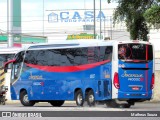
[108,0,154,41]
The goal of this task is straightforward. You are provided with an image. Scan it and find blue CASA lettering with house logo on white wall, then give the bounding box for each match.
[48,11,111,22]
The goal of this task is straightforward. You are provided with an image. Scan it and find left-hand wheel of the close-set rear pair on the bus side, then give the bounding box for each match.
[75,90,84,106]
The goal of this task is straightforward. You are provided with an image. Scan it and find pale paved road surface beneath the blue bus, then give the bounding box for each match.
[0,102,160,111]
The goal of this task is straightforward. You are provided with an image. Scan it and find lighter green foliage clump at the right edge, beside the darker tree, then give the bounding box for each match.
[144,0,160,28]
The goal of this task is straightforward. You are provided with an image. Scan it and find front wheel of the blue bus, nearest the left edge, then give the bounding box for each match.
[20,90,35,106]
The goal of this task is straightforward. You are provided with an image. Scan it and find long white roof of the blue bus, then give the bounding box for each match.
[22,39,151,50]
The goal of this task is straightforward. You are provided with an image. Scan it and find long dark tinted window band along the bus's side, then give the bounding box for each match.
[25,47,112,66]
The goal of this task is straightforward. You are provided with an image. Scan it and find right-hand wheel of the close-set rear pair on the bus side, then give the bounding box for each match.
[87,90,95,106]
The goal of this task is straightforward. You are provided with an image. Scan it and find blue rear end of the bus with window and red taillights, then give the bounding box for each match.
[114,43,154,97]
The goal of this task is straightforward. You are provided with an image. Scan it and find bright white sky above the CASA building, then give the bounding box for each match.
[0,0,117,31]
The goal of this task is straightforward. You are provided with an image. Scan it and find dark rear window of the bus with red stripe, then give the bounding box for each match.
[118,43,153,62]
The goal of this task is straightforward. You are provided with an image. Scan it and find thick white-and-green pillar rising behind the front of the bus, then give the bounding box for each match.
[7,0,21,47]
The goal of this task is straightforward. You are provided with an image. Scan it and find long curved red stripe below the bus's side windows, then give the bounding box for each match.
[26,60,110,72]
